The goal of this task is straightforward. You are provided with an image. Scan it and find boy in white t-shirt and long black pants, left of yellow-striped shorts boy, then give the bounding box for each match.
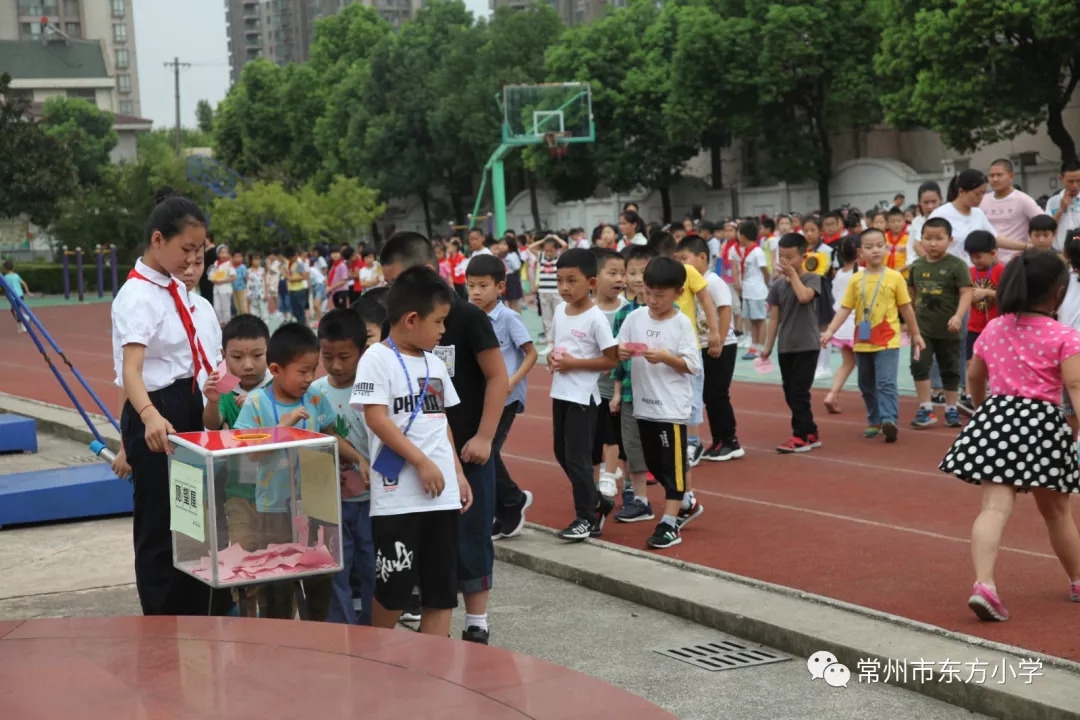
[548,248,618,541]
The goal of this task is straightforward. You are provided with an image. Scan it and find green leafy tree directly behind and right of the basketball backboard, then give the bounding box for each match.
[546,0,697,220]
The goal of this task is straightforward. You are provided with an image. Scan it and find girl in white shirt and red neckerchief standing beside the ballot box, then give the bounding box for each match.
[112,188,232,615]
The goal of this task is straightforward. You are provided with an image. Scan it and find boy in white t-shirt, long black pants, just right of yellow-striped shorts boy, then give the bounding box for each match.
[675,235,746,467]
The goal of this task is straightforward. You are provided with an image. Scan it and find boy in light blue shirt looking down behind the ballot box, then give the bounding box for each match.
[233,323,361,620]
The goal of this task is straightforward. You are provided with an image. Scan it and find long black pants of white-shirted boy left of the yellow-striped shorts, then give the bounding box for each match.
[551,399,599,522]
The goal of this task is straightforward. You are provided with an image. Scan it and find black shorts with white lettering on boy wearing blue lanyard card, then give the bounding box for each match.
[372,510,460,610]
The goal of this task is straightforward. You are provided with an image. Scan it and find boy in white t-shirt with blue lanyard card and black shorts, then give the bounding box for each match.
[350,267,472,638]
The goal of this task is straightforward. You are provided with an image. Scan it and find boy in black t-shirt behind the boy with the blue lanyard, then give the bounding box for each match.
[379,232,510,644]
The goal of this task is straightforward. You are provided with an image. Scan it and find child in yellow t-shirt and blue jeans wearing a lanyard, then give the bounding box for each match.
[821,229,927,443]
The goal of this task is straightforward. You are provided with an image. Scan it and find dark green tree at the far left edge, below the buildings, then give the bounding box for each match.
[0,72,76,226]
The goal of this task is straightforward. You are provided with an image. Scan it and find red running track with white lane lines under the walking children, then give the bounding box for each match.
[6,304,1080,661]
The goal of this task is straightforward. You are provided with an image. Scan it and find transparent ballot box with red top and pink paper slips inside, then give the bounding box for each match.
[168,427,341,587]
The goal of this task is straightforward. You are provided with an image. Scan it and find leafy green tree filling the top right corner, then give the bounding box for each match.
[875,0,1080,161]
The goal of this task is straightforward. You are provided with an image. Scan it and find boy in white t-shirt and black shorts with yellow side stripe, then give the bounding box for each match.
[618,257,701,549]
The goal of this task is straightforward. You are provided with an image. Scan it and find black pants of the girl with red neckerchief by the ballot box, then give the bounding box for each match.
[120,378,232,615]
